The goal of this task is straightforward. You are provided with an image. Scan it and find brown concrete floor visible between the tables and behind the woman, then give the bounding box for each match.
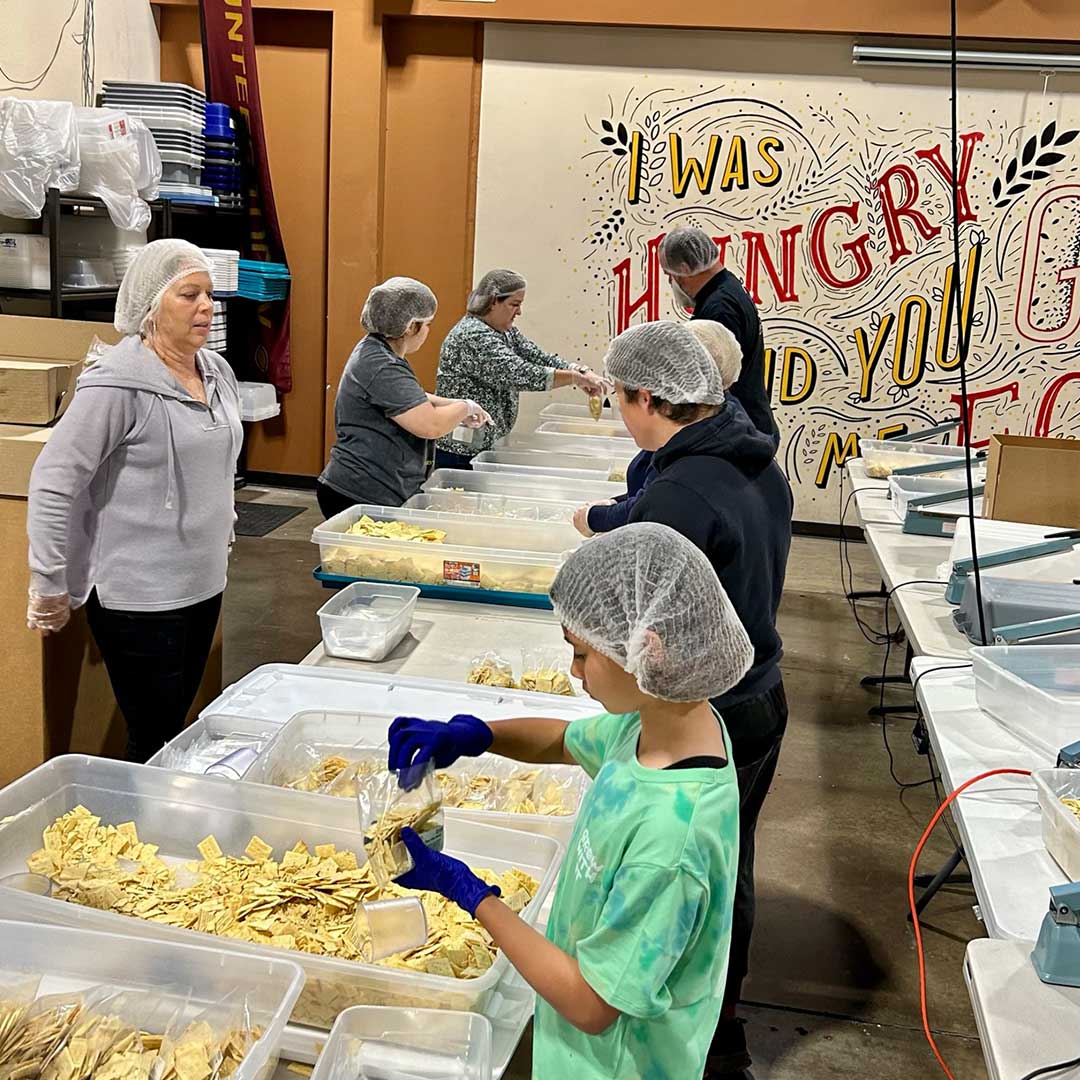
[234,488,986,1080]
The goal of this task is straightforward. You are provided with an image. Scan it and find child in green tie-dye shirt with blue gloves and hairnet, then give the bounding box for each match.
[390,524,752,1080]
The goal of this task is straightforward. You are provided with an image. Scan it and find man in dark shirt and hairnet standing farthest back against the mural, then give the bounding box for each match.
[660,229,780,446]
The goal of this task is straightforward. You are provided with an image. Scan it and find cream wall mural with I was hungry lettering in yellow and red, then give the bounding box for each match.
[477,27,1080,523]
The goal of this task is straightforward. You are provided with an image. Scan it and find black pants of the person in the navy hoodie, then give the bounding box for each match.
[707,683,787,1075]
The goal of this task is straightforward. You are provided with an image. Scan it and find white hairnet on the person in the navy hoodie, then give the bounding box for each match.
[605,322,724,405]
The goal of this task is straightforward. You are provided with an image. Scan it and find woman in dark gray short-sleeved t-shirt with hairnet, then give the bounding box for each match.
[316,278,490,517]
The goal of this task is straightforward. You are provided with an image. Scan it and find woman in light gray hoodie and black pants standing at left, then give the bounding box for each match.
[27,240,243,761]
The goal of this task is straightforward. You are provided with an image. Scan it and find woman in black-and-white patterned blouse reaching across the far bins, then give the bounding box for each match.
[435,270,604,469]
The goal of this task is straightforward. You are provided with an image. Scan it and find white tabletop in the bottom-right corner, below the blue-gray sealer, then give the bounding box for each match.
[963,940,1080,1080]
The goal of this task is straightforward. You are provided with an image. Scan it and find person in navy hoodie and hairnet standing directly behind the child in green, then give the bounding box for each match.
[607,322,793,1080]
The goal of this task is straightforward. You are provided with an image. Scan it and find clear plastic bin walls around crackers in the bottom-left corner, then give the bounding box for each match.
[0,920,303,1080]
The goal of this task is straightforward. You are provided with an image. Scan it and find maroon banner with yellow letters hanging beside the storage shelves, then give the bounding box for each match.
[199,0,293,393]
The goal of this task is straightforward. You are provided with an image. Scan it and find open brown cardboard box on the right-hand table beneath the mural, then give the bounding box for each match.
[983,435,1080,528]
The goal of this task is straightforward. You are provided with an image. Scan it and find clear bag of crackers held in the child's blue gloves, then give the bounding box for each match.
[356,761,443,886]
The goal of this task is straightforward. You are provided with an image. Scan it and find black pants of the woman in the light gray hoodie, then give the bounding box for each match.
[86,590,221,761]
